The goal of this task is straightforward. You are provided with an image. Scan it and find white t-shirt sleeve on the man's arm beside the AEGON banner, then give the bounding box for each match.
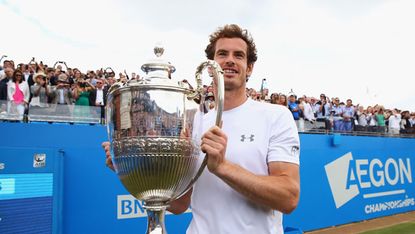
[267,109,300,165]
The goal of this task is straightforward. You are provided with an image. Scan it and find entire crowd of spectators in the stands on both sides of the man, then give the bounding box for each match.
[0,58,415,135]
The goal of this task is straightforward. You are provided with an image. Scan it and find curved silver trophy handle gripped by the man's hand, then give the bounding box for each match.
[176,60,225,199]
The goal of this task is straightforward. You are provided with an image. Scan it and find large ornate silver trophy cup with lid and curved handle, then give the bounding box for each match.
[106,46,224,234]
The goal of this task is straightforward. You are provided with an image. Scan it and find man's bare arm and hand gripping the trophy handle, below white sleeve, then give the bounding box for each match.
[202,127,300,213]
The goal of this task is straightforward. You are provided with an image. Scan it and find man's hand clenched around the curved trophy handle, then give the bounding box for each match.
[201,126,228,174]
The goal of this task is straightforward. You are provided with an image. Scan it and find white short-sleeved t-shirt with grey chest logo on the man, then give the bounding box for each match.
[187,98,300,234]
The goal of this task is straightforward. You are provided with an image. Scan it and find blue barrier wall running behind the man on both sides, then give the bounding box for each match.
[0,123,415,234]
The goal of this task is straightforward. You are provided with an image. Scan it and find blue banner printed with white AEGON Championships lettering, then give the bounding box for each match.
[284,135,415,231]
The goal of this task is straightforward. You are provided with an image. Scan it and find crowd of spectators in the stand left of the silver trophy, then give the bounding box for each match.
[0,59,120,120]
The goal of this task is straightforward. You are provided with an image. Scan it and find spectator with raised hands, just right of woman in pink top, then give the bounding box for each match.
[30,72,52,109]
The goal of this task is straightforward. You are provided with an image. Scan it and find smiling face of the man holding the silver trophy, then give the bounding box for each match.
[214,38,253,91]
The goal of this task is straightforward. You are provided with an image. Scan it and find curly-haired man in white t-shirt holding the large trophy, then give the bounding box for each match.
[103,25,300,233]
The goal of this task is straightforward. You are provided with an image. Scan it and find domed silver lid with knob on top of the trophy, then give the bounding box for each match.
[141,43,176,79]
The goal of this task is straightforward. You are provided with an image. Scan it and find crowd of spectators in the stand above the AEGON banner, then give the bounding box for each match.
[247,89,415,135]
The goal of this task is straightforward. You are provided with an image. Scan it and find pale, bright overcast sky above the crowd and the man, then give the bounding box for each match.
[0,0,415,111]
